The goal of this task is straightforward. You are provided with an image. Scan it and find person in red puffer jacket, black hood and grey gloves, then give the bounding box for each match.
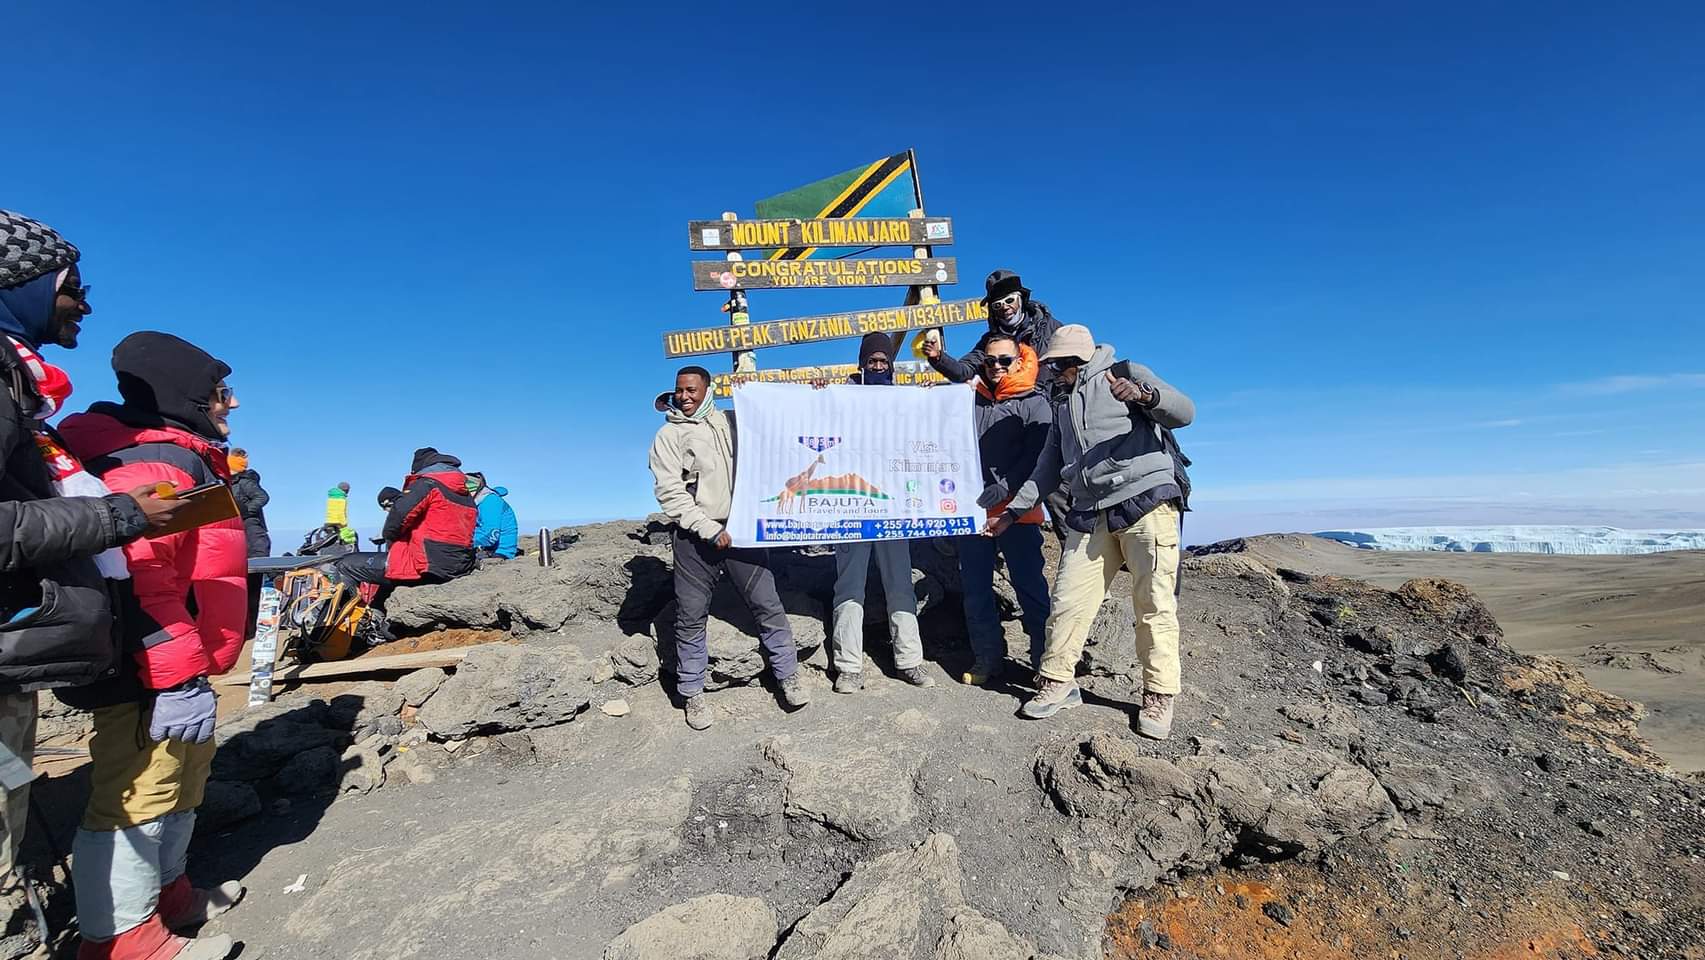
[60,333,249,960]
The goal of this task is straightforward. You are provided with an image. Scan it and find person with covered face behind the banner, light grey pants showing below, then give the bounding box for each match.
[834,333,936,694]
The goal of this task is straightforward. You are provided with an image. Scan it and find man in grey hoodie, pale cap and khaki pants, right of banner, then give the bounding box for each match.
[984,324,1195,740]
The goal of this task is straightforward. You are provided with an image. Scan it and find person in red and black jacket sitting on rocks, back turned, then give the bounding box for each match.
[338,447,479,607]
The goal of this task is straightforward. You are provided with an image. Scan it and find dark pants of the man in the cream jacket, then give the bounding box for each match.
[672,529,800,697]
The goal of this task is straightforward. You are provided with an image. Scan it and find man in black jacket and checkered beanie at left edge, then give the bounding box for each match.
[0,210,179,938]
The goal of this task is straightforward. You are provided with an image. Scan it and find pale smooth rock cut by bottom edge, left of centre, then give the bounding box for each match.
[604,893,777,960]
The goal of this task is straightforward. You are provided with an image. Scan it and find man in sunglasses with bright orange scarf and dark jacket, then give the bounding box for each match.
[958,334,1054,684]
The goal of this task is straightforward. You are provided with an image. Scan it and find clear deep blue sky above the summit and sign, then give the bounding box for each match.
[0,0,1705,546]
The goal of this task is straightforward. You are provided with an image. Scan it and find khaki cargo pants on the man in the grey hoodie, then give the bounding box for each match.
[1042,503,1178,694]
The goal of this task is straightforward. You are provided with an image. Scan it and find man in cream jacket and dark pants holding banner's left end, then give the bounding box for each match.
[650,367,812,730]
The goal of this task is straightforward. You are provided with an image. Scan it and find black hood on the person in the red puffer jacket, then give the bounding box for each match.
[113,331,230,442]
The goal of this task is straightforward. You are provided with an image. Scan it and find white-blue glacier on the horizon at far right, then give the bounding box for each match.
[1315,525,1705,554]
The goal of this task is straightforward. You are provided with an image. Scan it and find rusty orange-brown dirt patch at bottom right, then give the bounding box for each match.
[1107,863,1601,960]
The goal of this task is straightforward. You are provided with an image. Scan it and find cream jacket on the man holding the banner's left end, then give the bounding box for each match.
[650,406,735,541]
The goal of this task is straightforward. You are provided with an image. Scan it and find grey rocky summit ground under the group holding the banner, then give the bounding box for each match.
[20,522,1705,960]
